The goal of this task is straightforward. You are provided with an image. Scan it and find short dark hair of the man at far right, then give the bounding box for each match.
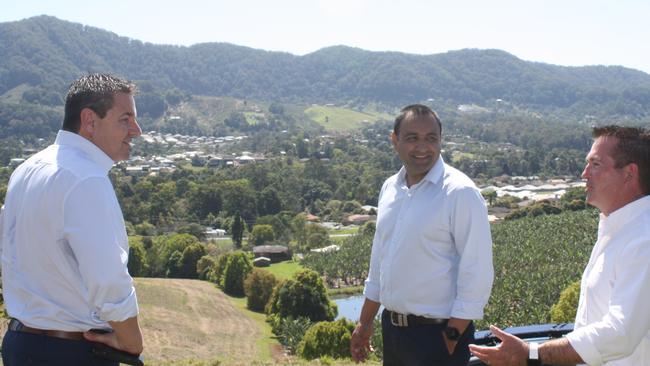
[592,125,650,195]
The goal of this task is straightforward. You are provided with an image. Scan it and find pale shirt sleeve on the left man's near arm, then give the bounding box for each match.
[63,177,138,321]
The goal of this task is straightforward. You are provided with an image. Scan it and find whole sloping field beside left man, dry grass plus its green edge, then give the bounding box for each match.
[136,276,377,366]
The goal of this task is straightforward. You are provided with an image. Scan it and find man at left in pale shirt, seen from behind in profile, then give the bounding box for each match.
[0,74,142,366]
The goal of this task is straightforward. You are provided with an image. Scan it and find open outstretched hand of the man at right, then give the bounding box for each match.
[469,325,528,366]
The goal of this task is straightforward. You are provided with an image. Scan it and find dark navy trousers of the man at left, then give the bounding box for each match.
[2,330,118,366]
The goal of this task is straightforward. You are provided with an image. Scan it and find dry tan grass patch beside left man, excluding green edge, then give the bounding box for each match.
[136,278,261,364]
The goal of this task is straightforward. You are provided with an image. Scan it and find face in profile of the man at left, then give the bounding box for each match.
[90,93,142,162]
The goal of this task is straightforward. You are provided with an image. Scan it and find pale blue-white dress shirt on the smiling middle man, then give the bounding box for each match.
[364,157,494,319]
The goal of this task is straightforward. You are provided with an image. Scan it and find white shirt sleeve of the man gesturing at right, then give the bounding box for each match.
[566,236,650,365]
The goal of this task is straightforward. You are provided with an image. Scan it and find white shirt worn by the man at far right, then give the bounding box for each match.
[567,196,650,366]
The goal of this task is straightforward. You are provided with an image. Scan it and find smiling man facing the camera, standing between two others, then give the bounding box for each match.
[350,104,493,366]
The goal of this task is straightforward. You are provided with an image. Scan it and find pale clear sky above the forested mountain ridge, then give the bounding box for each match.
[0,0,650,73]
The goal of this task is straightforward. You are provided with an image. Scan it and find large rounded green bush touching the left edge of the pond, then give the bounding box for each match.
[266,269,338,321]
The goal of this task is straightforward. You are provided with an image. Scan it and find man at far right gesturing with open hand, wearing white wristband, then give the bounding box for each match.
[470,126,650,366]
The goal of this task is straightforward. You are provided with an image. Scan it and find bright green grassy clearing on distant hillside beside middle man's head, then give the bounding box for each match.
[305,105,393,131]
